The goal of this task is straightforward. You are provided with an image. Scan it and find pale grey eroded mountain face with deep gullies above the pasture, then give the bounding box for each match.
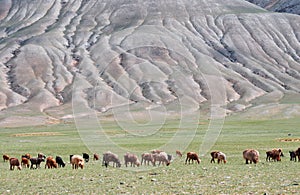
[0,0,300,124]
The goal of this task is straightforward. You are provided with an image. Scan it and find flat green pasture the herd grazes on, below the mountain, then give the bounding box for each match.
[0,117,300,194]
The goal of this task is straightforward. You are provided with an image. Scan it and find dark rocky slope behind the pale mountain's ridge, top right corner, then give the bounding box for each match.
[247,0,300,15]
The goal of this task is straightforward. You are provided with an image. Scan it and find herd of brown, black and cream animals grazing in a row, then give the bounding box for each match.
[3,147,300,170]
